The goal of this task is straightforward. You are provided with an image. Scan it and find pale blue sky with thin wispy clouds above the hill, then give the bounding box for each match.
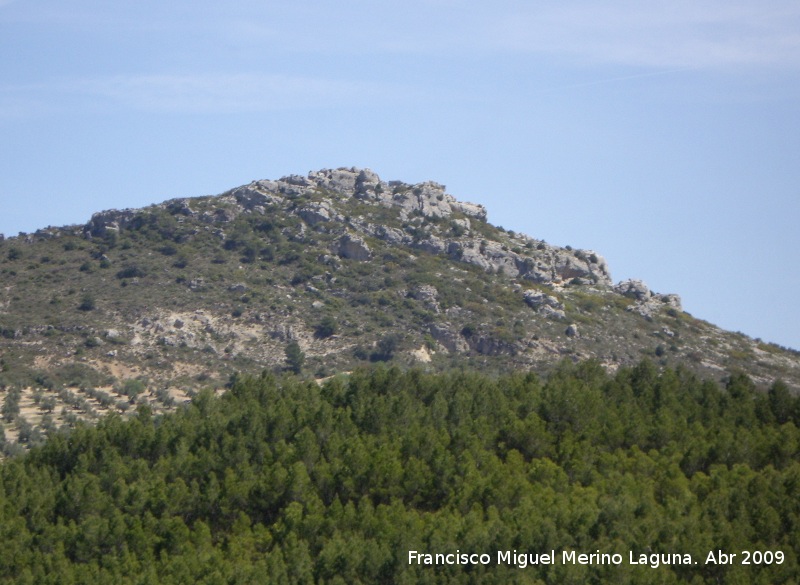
[0,0,800,348]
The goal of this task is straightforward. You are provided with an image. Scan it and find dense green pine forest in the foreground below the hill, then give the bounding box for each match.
[0,362,800,585]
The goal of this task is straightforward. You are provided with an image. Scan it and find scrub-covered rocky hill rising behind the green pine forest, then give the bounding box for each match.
[0,168,800,442]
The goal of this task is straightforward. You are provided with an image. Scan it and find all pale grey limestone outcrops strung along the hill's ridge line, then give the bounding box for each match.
[75,167,680,302]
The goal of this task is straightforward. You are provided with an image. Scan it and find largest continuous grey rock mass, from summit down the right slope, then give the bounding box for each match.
[228,167,612,286]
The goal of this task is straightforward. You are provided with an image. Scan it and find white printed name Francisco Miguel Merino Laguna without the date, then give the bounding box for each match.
[408,550,694,569]
